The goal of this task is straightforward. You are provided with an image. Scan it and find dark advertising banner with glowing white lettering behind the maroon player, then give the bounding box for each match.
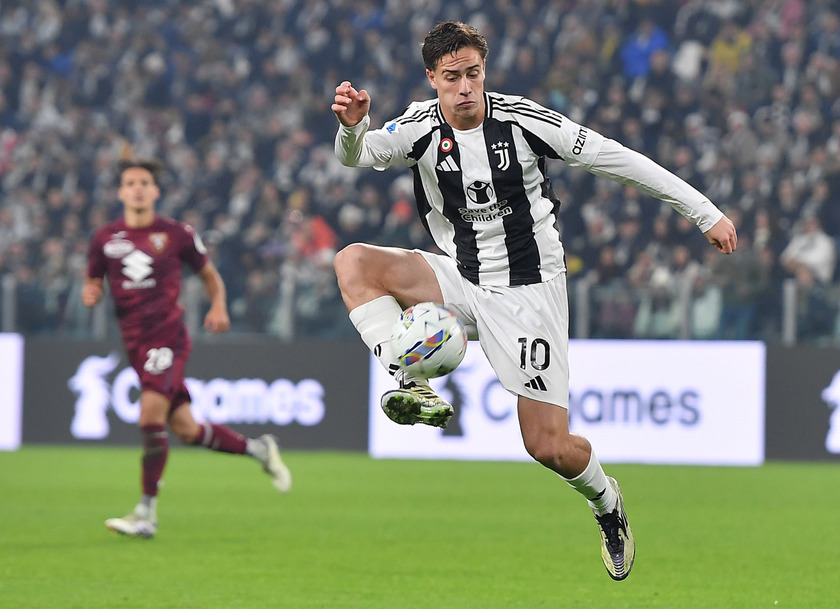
[23,339,368,450]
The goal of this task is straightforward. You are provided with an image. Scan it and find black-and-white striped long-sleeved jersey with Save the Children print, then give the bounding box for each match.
[335,92,722,286]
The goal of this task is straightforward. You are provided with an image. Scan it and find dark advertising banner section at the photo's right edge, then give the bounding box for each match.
[767,346,840,461]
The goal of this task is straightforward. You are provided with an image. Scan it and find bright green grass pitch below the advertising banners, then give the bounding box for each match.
[0,446,840,609]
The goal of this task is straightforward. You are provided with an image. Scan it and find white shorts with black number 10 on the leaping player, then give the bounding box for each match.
[415,250,569,408]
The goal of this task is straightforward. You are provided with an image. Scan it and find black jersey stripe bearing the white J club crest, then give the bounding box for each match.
[484,119,540,285]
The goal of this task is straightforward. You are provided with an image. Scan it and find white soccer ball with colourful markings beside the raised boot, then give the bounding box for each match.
[391,302,467,378]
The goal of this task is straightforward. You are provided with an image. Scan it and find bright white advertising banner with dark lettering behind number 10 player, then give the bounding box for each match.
[370,340,765,465]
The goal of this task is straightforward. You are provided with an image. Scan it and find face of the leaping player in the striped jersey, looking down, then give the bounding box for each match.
[426,47,484,129]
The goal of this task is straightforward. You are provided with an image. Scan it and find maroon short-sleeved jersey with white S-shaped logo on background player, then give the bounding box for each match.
[88,216,207,352]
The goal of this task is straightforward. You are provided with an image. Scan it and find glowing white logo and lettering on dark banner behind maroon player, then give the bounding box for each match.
[68,353,326,440]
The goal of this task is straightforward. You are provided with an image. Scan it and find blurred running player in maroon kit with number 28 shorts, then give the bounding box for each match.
[82,160,292,538]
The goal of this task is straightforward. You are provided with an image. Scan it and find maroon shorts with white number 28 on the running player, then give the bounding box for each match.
[128,328,192,412]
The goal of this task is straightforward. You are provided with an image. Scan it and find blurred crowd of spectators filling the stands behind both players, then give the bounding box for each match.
[0,0,840,341]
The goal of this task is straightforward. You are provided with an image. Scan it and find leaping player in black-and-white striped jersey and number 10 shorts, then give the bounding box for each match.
[332,21,737,580]
